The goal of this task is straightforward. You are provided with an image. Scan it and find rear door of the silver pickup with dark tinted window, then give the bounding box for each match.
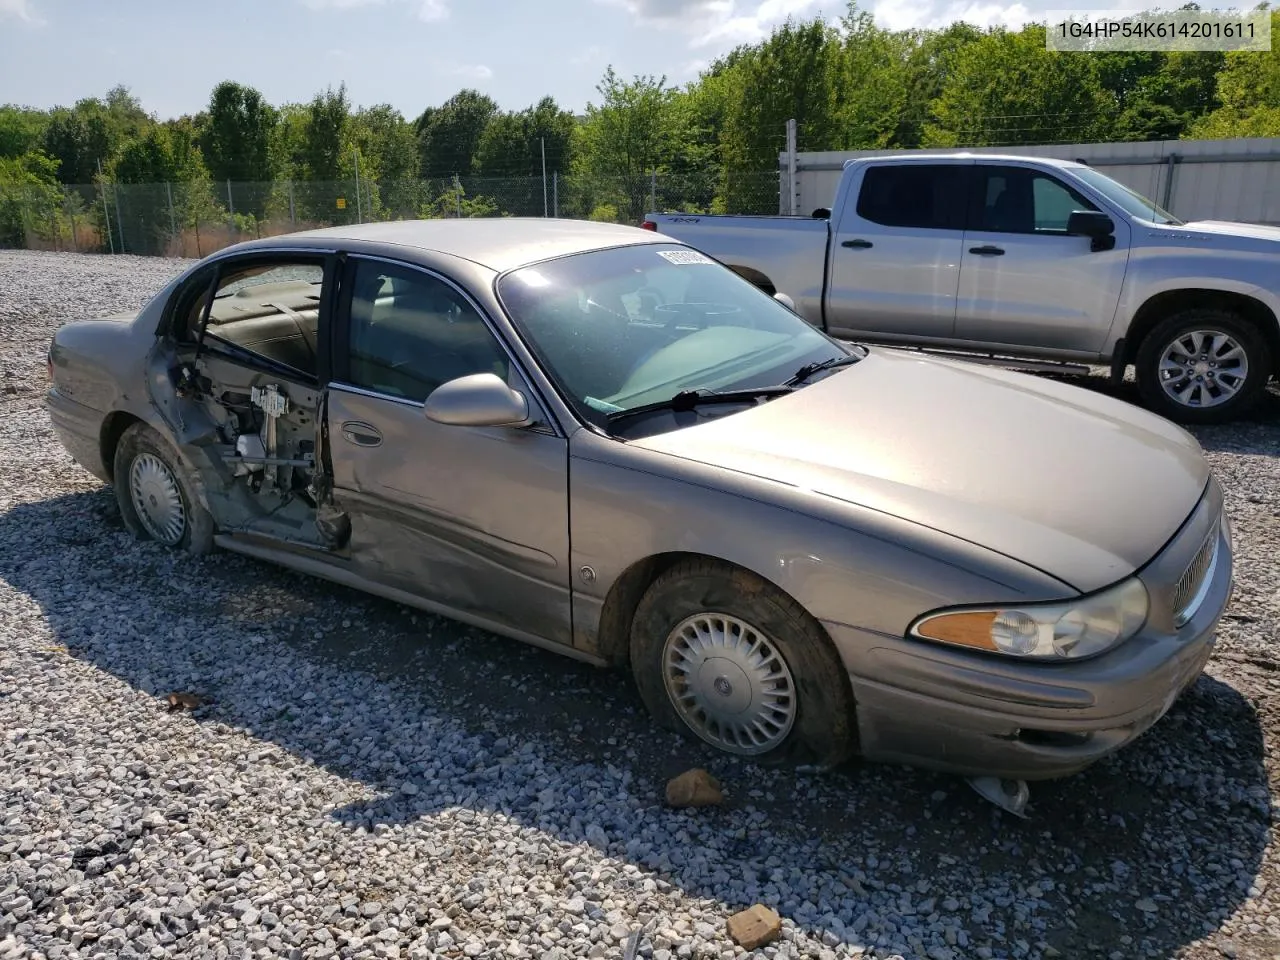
[827,159,973,343]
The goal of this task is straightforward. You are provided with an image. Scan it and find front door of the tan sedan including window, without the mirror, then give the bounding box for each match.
[326,255,572,645]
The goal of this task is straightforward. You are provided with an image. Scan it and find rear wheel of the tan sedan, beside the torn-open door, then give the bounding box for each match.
[114,424,214,553]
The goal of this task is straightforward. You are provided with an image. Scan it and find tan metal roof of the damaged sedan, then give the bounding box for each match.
[242,216,678,273]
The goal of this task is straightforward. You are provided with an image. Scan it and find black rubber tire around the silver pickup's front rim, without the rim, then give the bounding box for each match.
[1134,307,1272,424]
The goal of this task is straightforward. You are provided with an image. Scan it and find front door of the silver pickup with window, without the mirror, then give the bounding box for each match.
[956,160,1129,356]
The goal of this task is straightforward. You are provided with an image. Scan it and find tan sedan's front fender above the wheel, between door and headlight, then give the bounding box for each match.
[570,431,1074,653]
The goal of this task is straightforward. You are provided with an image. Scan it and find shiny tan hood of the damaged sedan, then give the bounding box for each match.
[634,349,1208,591]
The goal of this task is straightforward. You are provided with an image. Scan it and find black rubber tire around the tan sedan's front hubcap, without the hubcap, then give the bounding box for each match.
[631,559,858,768]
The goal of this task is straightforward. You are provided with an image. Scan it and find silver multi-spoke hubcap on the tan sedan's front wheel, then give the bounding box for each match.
[662,613,796,755]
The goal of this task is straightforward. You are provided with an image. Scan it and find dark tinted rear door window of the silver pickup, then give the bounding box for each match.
[858,163,968,230]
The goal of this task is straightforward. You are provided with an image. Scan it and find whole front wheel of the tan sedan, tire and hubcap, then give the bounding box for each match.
[631,559,856,767]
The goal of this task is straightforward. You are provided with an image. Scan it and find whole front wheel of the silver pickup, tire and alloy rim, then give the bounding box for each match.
[1134,307,1271,424]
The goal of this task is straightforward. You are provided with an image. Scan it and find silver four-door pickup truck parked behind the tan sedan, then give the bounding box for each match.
[644,154,1280,424]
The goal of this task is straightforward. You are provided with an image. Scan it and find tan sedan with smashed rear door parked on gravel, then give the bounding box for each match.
[47,219,1231,798]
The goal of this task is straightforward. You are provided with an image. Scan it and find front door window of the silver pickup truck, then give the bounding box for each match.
[969,164,1097,234]
